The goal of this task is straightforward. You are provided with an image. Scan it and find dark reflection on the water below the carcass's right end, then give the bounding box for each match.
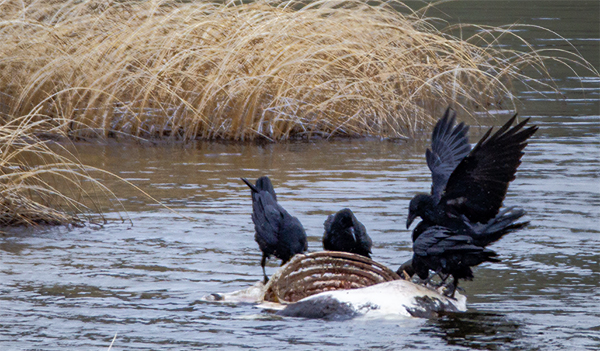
[421,312,523,350]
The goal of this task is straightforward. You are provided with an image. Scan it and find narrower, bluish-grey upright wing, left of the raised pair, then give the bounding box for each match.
[425,107,471,203]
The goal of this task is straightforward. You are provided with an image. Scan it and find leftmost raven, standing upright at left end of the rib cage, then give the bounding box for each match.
[241,176,308,284]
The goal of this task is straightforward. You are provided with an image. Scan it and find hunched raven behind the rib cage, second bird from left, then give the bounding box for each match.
[323,208,373,258]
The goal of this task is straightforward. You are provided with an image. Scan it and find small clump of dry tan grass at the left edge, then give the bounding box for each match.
[0,114,123,226]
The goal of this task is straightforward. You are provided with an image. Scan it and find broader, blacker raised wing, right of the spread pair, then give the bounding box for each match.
[439,114,537,223]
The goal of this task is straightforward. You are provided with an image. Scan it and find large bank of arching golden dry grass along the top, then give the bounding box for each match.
[0,0,597,140]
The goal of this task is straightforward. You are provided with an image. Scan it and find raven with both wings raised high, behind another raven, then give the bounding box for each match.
[406,108,538,234]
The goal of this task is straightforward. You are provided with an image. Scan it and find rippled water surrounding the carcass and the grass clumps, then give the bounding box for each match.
[0,1,600,350]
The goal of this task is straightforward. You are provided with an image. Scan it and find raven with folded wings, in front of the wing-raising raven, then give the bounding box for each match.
[412,208,529,297]
